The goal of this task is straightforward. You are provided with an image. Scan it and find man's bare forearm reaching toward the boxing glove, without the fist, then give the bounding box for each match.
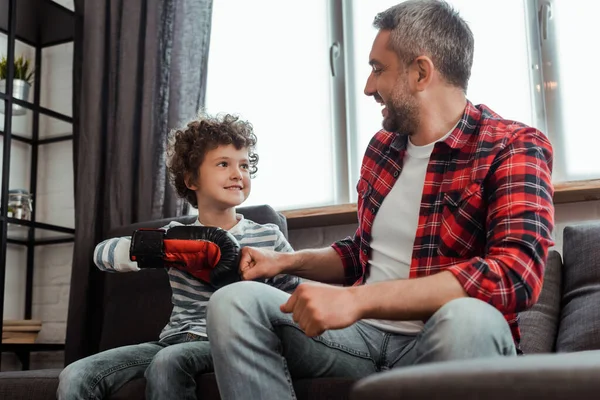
[281,247,344,283]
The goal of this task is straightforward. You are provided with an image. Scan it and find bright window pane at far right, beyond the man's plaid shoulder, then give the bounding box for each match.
[537,0,600,181]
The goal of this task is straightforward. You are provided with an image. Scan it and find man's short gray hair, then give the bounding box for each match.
[373,0,475,93]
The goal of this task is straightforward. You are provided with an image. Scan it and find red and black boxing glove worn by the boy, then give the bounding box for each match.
[129,226,240,288]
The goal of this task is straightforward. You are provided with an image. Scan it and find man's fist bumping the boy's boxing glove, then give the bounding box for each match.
[240,247,285,281]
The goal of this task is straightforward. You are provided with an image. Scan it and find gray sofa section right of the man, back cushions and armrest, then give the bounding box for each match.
[351,223,600,400]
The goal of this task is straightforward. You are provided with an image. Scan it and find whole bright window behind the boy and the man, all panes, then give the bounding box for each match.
[207,0,600,209]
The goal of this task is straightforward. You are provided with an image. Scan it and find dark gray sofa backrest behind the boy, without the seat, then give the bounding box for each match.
[99,205,288,351]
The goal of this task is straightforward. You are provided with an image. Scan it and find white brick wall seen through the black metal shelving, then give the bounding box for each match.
[0,0,75,371]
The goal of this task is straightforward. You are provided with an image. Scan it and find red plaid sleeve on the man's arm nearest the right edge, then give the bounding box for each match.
[448,128,554,314]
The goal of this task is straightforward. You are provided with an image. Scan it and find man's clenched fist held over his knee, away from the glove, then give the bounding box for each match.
[280,283,361,337]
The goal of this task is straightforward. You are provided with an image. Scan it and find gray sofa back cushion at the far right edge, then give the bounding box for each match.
[556,223,600,352]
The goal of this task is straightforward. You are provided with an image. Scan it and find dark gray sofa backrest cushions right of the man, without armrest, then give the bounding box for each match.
[519,222,600,354]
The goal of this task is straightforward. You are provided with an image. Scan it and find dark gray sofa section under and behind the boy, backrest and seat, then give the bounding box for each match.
[0,206,353,400]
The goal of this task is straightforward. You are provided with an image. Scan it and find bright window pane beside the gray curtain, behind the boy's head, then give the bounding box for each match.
[206,0,335,208]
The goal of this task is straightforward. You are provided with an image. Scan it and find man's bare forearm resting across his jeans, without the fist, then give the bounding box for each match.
[348,271,467,321]
